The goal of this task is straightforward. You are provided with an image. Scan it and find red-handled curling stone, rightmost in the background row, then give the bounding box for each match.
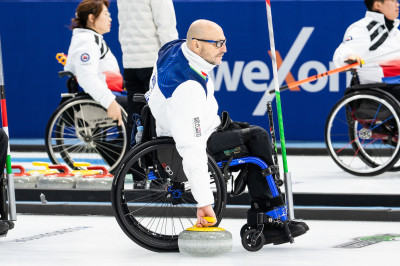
[76,166,114,190]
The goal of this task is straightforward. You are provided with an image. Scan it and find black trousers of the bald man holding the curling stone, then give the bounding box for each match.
[208,126,276,223]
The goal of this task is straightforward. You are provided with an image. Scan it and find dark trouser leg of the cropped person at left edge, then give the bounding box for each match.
[0,128,8,220]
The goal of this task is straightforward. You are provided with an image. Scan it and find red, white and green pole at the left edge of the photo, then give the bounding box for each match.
[0,38,17,221]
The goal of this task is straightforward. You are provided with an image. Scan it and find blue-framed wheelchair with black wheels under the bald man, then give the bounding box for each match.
[111,95,293,252]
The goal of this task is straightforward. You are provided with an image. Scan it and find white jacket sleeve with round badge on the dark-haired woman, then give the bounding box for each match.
[66,38,115,109]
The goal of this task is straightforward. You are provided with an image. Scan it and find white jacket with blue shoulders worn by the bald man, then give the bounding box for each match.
[146,40,221,207]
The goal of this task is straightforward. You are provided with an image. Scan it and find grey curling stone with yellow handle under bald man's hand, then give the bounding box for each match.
[178,217,232,257]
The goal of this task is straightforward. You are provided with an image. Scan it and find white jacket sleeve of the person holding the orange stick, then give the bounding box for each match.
[333,24,371,67]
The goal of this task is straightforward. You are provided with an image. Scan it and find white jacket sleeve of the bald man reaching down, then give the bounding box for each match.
[167,81,214,207]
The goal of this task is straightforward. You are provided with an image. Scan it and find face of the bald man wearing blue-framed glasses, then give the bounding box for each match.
[199,31,227,65]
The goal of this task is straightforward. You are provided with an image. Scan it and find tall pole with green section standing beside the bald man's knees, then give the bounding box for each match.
[265,0,294,219]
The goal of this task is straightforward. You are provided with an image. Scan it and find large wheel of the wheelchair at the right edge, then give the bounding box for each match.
[325,91,400,176]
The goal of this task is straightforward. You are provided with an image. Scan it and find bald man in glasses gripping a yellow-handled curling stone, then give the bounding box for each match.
[146,20,308,244]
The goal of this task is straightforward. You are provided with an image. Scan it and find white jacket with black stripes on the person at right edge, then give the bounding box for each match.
[333,11,400,84]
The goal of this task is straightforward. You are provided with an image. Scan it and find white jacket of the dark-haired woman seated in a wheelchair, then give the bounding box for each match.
[64,28,122,109]
